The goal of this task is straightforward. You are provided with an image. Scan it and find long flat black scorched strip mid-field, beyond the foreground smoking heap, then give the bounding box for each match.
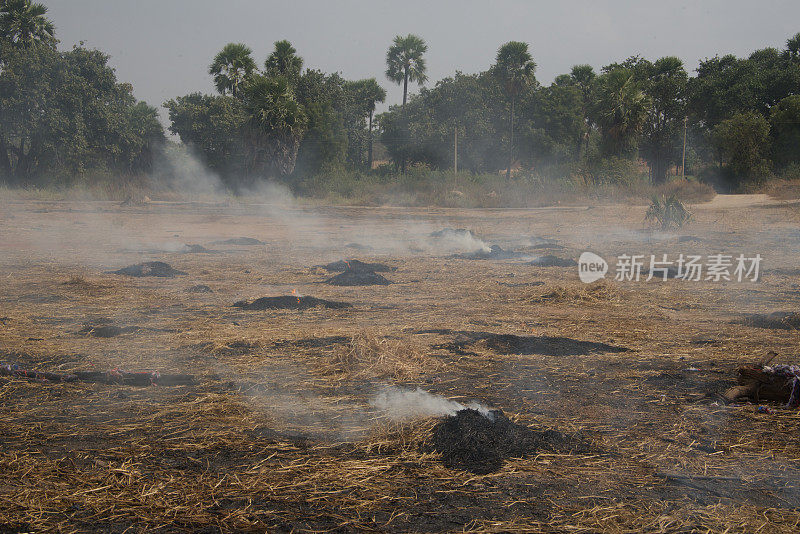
[424,329,631,356]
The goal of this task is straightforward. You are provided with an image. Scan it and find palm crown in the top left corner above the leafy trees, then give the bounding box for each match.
[0,0,56,48]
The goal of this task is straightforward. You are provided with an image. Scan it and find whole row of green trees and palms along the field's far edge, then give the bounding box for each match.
[0,0,800,193]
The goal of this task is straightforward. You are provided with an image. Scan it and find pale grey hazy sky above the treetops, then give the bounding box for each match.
[47,0,800,123]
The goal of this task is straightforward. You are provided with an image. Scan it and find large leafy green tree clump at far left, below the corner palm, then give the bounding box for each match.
[0,46,164,184]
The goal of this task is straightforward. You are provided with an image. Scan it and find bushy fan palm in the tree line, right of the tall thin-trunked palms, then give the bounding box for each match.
[592,67,650,156]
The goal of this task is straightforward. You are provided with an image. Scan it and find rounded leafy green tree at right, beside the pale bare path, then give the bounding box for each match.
[713,111,770,188]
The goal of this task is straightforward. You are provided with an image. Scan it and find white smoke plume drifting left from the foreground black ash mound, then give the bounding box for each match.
[370,386,491,421]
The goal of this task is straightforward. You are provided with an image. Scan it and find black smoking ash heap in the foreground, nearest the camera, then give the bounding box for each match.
[432,408,589,474]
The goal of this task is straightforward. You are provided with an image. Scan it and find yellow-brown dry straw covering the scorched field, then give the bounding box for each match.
[0,200,800,534]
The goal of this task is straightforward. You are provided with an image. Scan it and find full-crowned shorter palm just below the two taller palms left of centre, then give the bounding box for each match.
[242,75,308,180]
